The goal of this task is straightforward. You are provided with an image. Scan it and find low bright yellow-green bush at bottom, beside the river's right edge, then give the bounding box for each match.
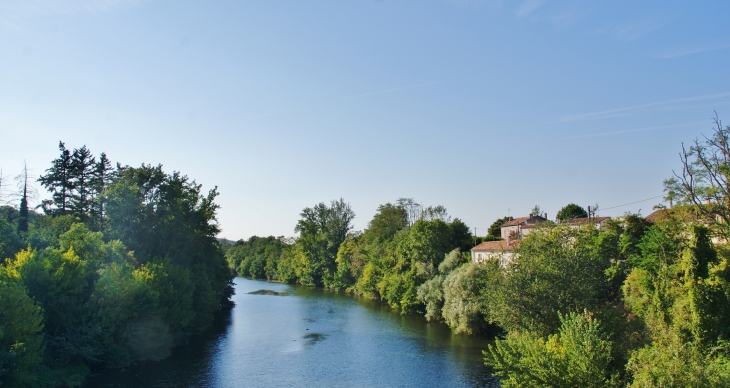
[484,312,620,388]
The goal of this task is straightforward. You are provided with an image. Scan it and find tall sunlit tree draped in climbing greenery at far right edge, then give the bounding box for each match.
[623,224,730,387]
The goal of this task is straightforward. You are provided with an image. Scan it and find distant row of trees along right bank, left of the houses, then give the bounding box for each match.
[226,199,474,313]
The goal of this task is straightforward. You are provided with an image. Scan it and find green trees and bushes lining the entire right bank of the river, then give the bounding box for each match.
[226,120,730,387]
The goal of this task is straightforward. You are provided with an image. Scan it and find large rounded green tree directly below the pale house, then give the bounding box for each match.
[490,226,611,335]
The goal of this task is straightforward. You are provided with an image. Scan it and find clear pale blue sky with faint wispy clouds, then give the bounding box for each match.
[0,0,730,240]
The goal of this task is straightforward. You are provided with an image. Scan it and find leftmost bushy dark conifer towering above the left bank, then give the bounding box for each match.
[38,141,74,214]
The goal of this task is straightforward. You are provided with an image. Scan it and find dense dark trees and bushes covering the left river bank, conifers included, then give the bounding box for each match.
[0,143,233,387]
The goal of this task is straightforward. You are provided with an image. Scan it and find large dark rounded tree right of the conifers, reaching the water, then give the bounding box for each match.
[105,165,233,333]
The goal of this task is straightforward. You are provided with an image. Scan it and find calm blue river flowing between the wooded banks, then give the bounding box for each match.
[87,278,498,388]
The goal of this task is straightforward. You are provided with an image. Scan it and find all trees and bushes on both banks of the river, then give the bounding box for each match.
[0,121,730,387]
